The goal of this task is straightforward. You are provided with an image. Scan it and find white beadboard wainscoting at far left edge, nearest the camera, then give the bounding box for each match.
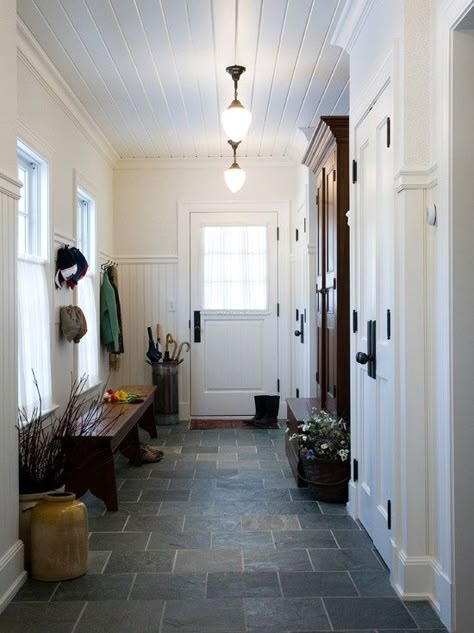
[0,173,26,611]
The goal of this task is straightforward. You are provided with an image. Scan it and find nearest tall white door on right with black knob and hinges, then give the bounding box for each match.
[351,86,394,568]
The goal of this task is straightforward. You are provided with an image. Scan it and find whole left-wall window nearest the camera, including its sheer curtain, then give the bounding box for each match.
[17,141,52,413]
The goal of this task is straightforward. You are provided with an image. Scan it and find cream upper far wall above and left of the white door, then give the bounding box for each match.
[114,159,297,257]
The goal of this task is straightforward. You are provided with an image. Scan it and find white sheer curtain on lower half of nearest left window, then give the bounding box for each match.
[18,259,52,413]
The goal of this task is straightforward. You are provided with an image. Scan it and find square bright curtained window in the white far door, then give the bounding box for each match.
[203,226,268,310]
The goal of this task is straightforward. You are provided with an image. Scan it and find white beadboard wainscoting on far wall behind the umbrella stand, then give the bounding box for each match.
[109,256,179,399]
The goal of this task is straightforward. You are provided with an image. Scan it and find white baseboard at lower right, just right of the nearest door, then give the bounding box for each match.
[393,550,452,630]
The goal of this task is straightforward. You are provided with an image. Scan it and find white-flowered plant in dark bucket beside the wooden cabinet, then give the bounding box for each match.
[290,409,350,503]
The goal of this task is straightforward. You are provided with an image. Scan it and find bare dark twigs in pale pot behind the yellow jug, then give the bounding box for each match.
[17,373,121,565]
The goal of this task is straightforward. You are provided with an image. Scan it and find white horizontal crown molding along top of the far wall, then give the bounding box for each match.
[114,156,298,170]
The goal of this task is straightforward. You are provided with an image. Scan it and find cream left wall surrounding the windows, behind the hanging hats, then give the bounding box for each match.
[18,56,114,405]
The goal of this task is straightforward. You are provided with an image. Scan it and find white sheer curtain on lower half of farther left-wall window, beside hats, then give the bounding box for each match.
[77,274,99,386]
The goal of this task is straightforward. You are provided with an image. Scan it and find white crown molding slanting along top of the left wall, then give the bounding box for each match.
[17,17,119,166]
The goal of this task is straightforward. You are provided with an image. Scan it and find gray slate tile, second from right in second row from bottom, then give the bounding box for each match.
[280,571,358,598]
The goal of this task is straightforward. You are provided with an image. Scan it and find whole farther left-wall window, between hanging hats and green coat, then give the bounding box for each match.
[76,189,99,386]
